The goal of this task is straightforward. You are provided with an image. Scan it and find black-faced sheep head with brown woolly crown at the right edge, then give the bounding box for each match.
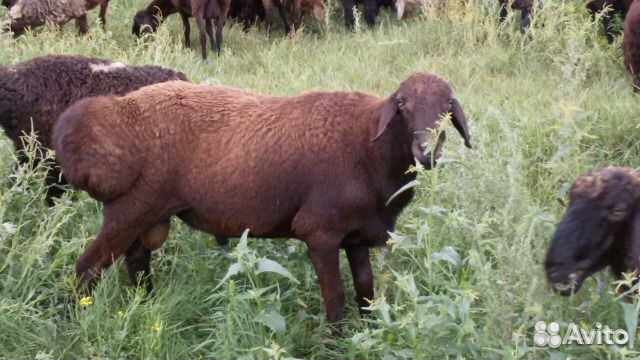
[545,167,640,296]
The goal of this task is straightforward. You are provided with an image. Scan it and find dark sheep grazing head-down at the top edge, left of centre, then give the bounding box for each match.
[131,0,230,59]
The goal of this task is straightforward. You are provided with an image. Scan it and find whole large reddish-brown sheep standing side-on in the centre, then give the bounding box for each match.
[53,74,471,322]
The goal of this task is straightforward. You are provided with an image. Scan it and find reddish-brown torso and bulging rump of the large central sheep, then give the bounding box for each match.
[54,81,408,236]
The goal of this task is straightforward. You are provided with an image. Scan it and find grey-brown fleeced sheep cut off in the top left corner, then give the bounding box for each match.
[9,0,109,37]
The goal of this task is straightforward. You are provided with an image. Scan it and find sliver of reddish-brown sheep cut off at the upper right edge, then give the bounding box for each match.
[622,0,640,92]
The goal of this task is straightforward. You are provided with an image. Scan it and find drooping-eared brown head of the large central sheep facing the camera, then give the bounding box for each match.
[373,73,471,169]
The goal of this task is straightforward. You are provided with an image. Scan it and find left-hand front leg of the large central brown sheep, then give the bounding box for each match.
[306,233,344,323]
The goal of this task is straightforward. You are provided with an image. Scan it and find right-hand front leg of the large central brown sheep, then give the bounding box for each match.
[345,246,373,315]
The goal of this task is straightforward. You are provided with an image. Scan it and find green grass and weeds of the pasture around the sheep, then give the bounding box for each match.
[0,0,640,360]
